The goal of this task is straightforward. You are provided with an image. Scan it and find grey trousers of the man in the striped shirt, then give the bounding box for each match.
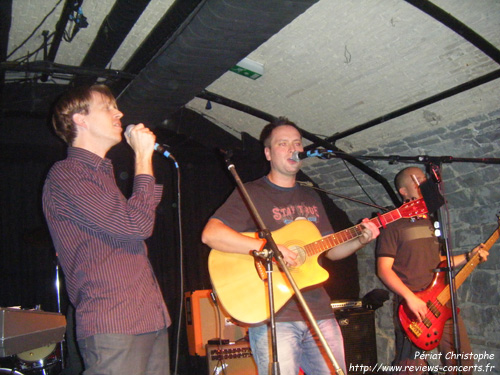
[78,328,170,375]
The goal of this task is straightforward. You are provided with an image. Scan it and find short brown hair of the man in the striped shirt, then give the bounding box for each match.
[52,85,115,146]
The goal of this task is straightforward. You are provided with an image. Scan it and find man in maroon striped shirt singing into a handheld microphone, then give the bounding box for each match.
[43,85,170,375]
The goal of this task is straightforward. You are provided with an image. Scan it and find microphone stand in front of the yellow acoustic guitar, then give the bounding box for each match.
[223,151,344,375]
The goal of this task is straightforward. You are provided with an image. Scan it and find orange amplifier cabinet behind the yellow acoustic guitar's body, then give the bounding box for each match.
[184,289,247,356]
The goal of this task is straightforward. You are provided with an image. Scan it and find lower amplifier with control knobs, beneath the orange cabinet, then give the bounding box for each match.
[206,341,257,375]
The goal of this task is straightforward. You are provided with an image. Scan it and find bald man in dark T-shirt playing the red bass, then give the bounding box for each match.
[376,167,488,374]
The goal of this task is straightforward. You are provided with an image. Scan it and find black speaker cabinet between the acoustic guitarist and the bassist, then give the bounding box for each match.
[334,309,377,374]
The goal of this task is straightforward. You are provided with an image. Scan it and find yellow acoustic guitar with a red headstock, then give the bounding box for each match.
[208,199,427,324]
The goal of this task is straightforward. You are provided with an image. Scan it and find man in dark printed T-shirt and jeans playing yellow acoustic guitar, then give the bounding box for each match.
[202,118,379,375]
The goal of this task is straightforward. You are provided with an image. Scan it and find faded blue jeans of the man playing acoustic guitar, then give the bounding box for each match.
[249,319,347,375]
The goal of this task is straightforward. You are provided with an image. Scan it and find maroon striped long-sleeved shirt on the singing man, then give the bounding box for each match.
[43,147,171,340]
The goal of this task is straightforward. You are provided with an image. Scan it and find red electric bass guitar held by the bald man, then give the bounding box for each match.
[398,220,500,350]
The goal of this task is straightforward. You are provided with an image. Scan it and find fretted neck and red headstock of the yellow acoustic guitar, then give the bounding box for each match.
[304,204,413,256]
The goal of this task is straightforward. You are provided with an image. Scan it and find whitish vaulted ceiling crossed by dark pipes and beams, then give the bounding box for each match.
[7,0,500,152]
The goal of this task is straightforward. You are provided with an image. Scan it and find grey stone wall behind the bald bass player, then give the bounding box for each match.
[303,110,500,374]
